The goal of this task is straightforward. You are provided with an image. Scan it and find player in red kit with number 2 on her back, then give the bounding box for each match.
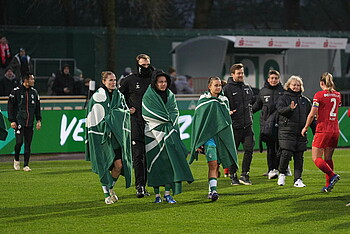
[301,72,341,192]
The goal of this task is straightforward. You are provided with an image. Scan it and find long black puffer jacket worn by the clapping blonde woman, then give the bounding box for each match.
[277,89,311,152]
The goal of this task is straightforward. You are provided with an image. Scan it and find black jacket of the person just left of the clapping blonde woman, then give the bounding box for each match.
[253,81,284,140]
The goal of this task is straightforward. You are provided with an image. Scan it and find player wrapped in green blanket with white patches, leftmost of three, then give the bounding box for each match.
[86,71,132,204]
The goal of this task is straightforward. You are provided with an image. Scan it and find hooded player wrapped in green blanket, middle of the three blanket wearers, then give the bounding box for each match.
[142,70,194,203]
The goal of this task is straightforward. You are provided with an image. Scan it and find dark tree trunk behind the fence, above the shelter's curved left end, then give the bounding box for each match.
[193,0,214,28]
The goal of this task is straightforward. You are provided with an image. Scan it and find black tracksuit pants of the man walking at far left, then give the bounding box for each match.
[15,127,34,167]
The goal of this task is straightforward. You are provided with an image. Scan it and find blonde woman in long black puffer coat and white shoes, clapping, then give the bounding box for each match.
[276,76,314,187]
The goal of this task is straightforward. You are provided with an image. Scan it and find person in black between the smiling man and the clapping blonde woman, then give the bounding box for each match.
[253,70,284,179]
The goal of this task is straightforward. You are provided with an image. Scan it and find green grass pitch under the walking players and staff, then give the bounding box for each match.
[0,149,350,233]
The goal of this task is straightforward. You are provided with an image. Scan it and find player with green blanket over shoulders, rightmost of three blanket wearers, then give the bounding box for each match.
[189,77,238,201]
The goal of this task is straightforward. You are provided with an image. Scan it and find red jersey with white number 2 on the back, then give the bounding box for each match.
[312,90,341,133]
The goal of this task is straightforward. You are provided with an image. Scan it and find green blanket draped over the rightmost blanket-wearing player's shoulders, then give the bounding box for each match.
[189,92,238,168]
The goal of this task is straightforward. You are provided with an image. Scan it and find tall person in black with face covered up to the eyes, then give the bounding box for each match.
[119,54,154,198]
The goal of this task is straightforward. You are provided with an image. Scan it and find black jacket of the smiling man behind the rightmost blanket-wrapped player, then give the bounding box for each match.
[224,77,254,129]
